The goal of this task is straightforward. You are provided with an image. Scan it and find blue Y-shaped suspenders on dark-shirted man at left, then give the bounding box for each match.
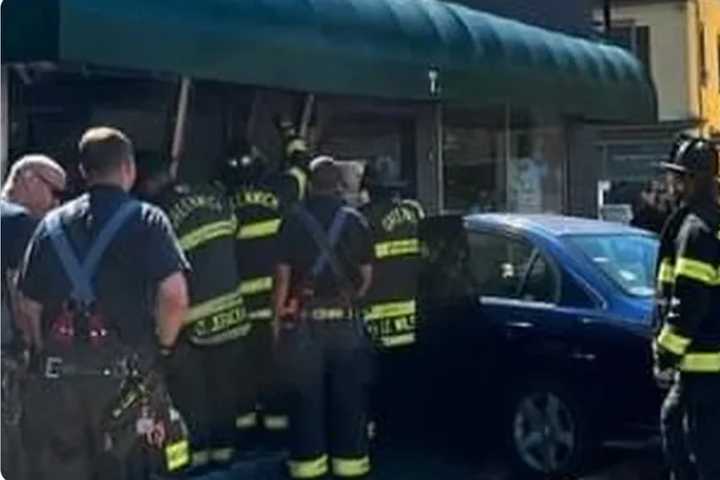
[46,201,140,304]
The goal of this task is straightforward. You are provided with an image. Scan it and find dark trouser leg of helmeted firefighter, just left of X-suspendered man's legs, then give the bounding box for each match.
[250,320,289,447]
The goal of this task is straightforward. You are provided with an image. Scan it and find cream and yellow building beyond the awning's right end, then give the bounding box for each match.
[595,0,720,213]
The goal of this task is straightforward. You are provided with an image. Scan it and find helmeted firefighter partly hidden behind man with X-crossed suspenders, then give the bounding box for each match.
[222,142,288,447]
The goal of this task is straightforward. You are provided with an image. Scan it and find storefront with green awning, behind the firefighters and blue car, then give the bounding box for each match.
[2,0,655,215]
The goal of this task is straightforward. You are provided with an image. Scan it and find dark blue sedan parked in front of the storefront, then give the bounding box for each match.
[418,214,662,478]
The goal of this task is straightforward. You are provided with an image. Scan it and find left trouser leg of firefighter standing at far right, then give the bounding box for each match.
[660,381,697,480]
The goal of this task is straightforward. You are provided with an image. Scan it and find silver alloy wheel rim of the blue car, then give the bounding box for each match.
[513,392,576,473]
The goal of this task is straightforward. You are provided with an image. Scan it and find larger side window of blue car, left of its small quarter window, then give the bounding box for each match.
[469,232,534,299]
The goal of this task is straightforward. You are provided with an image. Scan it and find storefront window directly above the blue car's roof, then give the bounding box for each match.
[443,109,567,213]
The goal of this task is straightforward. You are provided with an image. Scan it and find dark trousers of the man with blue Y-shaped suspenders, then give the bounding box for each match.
[21,374,127,480]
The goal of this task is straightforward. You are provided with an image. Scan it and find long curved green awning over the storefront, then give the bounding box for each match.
[2,0,656,122]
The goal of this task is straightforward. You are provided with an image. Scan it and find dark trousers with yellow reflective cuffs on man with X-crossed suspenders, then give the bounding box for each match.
[280,320,371,478]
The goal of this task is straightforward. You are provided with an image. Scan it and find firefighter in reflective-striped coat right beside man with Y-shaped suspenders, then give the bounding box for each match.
[139,156,254,471]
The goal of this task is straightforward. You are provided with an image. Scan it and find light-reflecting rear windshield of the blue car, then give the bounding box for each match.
[566,234,658,297]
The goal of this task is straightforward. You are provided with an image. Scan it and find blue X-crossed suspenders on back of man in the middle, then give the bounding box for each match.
[295,205,352,285]
